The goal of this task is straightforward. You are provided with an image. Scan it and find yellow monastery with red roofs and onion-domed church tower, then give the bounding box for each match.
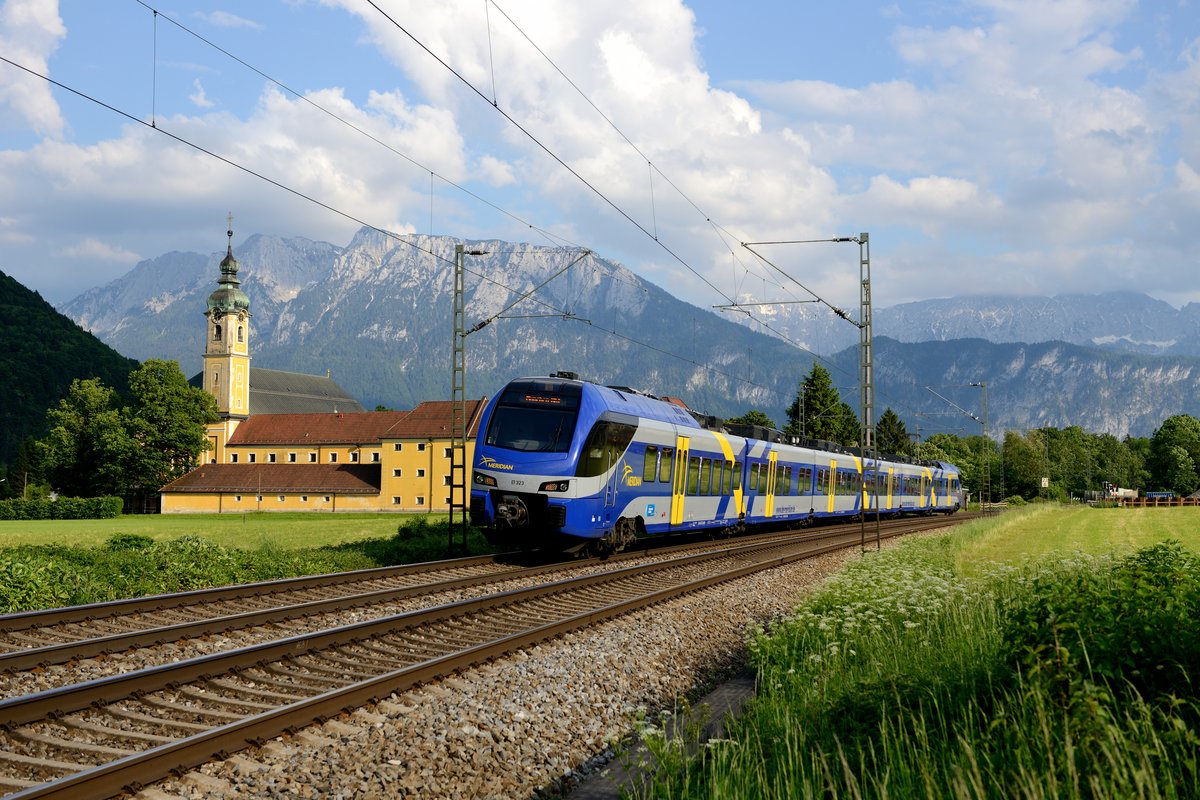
[162,226,485,513]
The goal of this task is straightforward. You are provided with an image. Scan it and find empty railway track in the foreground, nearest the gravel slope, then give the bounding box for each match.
[0,519,956,798]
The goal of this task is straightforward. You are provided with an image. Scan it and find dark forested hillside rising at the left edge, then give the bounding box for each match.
[0,272,138,464]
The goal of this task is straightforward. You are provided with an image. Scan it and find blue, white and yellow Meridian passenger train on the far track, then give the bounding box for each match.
[470,373,962,552]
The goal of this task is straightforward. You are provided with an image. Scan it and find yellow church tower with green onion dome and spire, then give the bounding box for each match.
[204,215,250,463]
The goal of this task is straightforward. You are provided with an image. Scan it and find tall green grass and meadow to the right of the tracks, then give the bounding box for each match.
[643,507,1200,800]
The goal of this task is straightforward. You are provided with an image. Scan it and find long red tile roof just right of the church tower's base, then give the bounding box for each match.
[228,411,410,447]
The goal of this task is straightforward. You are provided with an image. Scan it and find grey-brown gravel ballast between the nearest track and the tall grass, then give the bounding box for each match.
[138,548,862,800]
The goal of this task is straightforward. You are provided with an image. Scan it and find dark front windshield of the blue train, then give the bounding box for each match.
[485,383,581,452]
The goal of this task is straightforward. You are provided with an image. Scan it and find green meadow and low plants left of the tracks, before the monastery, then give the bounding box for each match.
[0,513,491,613]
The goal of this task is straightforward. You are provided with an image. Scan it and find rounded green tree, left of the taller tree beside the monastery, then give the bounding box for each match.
[44,378,132,497]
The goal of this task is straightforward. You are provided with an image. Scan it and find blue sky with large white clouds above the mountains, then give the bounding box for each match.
[0,0,1200,307]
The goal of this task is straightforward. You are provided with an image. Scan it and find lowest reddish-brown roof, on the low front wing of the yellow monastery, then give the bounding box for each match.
[161,464,380,494]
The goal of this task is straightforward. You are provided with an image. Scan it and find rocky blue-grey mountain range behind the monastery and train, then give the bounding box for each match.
[61,229,1200,437]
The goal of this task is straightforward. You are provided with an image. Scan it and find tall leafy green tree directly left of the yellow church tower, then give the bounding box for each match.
[124,359,217,495]
